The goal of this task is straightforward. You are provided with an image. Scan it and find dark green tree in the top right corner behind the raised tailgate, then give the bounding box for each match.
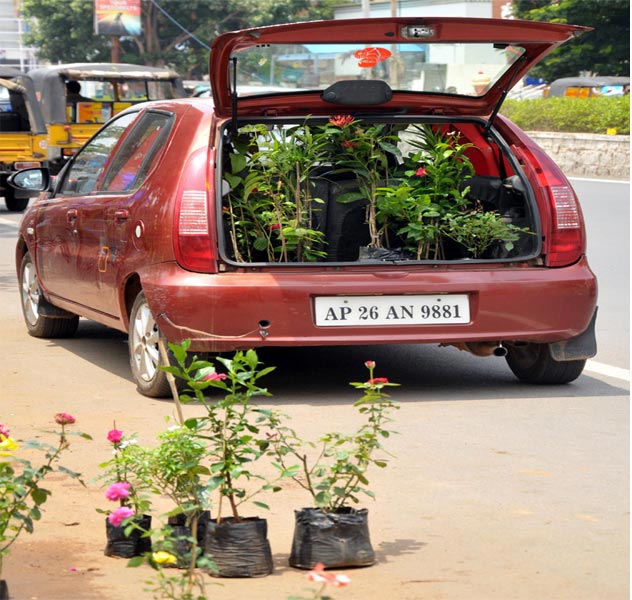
[512,0,630,81]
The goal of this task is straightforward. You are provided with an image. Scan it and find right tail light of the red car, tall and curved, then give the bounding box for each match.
[523,145,586,267]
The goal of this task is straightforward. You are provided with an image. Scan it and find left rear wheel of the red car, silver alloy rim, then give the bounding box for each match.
[128,292,177,398]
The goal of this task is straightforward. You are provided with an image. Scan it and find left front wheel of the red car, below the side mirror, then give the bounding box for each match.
[19,252,79,338]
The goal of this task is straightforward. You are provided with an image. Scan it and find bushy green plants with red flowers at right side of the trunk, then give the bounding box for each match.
[376,125,528,260]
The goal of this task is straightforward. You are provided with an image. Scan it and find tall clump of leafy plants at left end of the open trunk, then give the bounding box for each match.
[224,125,326,262]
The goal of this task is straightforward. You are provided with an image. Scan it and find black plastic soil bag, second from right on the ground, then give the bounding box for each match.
[204,517,272,577]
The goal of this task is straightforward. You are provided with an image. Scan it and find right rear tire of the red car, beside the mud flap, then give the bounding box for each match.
[506,343,586,385]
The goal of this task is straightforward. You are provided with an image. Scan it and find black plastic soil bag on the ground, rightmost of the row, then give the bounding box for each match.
[290,507,375,569]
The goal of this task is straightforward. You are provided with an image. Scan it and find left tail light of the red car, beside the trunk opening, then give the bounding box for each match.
[176,190,215,273]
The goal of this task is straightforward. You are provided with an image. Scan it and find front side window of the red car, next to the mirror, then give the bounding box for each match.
[58,112,138,196]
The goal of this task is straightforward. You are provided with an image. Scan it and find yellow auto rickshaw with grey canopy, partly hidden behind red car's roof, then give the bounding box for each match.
[29,63,186,172]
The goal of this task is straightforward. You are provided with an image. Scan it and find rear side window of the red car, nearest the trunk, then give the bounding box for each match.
[99,111,174,192]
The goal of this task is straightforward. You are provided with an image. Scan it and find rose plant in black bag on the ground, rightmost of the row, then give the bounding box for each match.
[270,361,398,569]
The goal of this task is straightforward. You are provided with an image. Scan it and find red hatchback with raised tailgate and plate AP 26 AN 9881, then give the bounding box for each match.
[13,17,597,396]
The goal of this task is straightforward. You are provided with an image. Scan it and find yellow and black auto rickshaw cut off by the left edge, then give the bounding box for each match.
[0,66,48,212]
